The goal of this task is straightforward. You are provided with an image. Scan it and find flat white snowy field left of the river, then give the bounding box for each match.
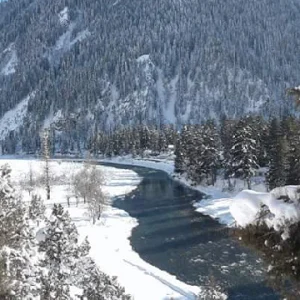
[0,159,200,300]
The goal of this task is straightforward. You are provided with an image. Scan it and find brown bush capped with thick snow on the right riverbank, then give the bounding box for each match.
[230,187,300,299]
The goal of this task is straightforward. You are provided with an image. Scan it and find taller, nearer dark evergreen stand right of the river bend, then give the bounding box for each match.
[175,116,300,189]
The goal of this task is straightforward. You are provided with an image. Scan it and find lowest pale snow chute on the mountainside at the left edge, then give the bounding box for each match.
[0,92,35,141]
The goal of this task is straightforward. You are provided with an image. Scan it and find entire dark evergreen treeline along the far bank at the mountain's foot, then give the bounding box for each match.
[88,116,300,189]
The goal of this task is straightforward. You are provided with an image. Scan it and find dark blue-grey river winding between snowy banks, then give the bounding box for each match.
[102,164,280,299]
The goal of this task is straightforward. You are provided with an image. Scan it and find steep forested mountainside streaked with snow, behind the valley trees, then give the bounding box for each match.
[0,0,300,153]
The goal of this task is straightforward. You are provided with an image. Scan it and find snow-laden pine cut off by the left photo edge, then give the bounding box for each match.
[0,165,39,300]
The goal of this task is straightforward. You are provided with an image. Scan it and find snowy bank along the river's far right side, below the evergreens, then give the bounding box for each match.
[103,156,300,239]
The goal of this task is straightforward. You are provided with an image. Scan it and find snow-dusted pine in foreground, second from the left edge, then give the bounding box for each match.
[40,204,89,300]
